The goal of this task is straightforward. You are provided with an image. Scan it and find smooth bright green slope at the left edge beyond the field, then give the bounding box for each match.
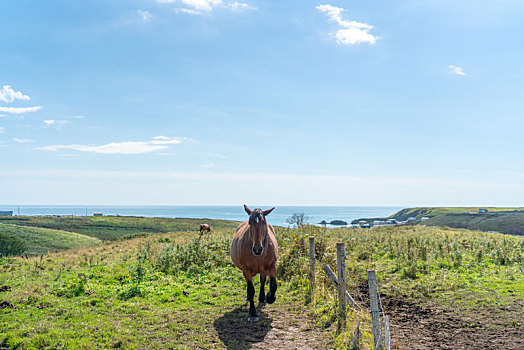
[0,223,101,254]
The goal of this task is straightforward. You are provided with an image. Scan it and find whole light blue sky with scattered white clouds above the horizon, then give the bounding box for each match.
[0,0,524,206]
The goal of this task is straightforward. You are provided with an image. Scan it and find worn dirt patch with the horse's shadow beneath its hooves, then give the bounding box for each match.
[214,306,329,350]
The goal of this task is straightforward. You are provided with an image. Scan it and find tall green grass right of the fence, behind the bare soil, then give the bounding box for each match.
[298,226,524,318]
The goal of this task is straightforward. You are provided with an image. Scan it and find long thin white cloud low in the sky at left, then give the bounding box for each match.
[37,136,191,154]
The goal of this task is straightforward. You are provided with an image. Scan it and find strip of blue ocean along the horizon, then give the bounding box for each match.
[0,205,402,226]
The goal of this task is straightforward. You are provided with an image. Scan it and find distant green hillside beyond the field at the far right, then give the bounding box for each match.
[424,213,524,235]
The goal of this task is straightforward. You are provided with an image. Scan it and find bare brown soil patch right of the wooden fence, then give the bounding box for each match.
[358,284,524,350]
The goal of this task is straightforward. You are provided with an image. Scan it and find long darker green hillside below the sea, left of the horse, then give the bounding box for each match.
[0,216,239,241]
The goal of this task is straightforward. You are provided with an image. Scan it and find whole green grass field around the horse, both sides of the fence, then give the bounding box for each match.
[0,220,524,349]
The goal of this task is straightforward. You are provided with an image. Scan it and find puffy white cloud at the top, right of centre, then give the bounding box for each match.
[316,4,379,45]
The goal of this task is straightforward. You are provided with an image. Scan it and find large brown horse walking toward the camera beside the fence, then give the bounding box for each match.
[231,205,278,321]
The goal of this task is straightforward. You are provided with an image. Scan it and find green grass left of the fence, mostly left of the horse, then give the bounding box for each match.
[0,231,334,349]
